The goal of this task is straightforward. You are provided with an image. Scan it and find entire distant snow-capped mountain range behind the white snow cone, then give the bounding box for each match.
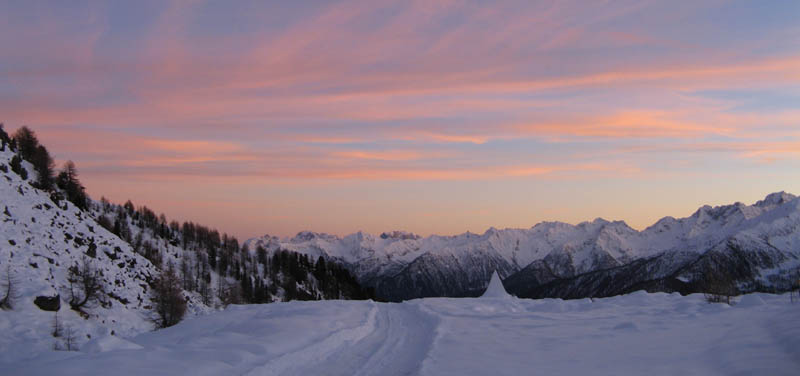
[246,192,800,300]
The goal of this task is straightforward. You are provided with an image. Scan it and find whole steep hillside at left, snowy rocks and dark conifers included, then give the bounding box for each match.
[0,130,371,361]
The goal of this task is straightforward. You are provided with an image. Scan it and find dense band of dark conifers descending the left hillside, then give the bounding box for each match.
[90,198,374,304]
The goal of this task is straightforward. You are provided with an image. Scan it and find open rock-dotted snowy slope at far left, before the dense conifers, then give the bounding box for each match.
[0,149,176,359]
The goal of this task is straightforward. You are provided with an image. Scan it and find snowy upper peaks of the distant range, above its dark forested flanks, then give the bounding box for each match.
[242,192,800,285]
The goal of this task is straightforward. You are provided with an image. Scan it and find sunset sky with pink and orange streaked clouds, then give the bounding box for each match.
[0,0,800,238]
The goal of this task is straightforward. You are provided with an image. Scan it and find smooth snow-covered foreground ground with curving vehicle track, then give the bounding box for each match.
[0,292,800,376]
